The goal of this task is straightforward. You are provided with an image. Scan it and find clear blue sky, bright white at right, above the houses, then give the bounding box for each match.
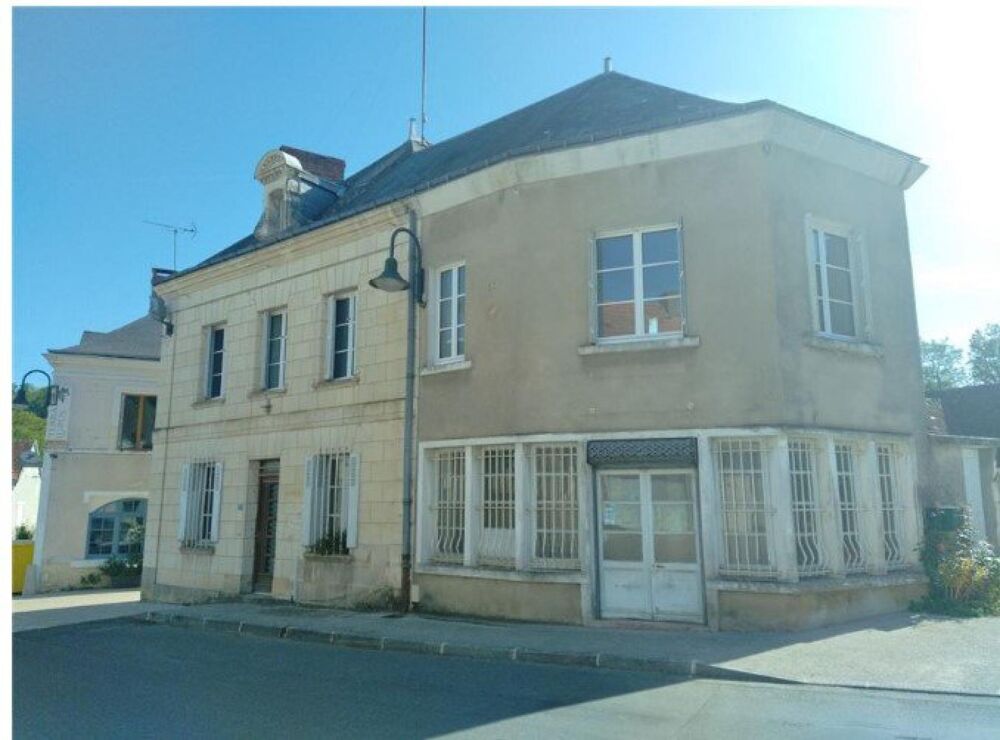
[13,8,1000,379]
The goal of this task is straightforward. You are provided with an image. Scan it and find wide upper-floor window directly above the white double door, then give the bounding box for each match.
[596,227,684,339]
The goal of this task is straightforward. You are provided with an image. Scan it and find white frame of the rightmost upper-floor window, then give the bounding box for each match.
[805,214,871,342]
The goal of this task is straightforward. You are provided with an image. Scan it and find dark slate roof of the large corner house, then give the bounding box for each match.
[174,72,916,277]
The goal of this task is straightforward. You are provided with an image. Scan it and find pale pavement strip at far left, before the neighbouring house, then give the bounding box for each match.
[13,589,149,632]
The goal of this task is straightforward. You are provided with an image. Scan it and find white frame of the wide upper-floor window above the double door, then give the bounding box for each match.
[590,221,687,344]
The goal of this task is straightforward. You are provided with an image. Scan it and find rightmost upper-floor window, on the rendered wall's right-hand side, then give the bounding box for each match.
[809,226,858,337]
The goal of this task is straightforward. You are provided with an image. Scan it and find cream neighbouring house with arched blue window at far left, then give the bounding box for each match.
[25,270,166,593]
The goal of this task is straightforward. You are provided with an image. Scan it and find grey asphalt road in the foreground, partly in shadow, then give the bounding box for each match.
[13,621,1000,740]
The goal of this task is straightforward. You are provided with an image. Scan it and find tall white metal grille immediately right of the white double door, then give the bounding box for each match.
[714,439,775,577]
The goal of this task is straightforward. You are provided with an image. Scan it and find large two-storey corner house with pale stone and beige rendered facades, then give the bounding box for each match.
[143,71,928,628]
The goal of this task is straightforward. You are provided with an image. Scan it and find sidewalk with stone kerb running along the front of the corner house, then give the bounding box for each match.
[140,602,1000,697]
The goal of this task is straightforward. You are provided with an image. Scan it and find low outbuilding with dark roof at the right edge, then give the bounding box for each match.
[927,383,1000,547]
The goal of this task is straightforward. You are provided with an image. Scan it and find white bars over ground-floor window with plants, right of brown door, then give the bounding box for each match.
[305,451,357,555]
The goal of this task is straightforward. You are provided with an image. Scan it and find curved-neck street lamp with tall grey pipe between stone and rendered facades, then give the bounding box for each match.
[368,225,425,609]
